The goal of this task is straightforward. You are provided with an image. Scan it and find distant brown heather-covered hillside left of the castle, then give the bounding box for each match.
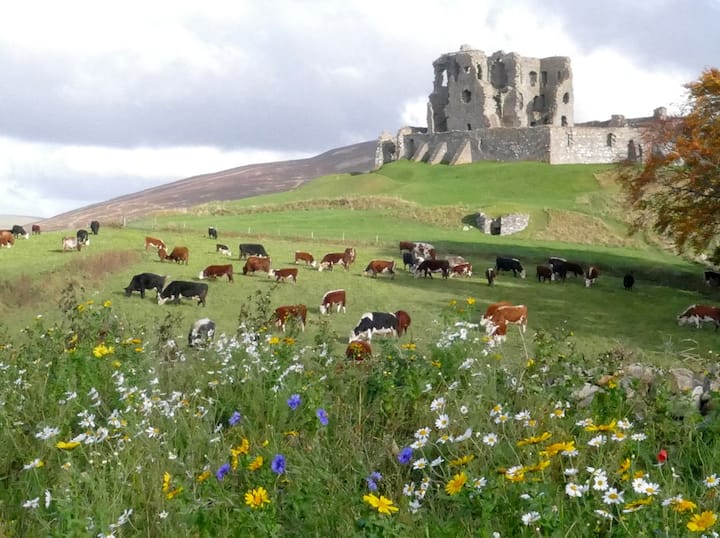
[35,141,377,230]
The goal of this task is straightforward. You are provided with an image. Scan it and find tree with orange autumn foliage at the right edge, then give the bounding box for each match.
[620,68,720,263]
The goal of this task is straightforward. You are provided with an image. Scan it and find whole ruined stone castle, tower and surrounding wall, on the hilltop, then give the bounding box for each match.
[376,45,665,167]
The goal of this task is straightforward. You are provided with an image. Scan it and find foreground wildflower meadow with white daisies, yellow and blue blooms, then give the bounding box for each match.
[0,284,720,538]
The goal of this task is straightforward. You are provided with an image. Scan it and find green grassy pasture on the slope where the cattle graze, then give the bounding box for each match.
[0,157,718,360]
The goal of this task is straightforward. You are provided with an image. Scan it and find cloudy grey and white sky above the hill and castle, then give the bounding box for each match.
[0,0,720,217]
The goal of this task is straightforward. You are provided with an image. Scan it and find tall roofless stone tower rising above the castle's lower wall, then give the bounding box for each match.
[428,45,573,133]
